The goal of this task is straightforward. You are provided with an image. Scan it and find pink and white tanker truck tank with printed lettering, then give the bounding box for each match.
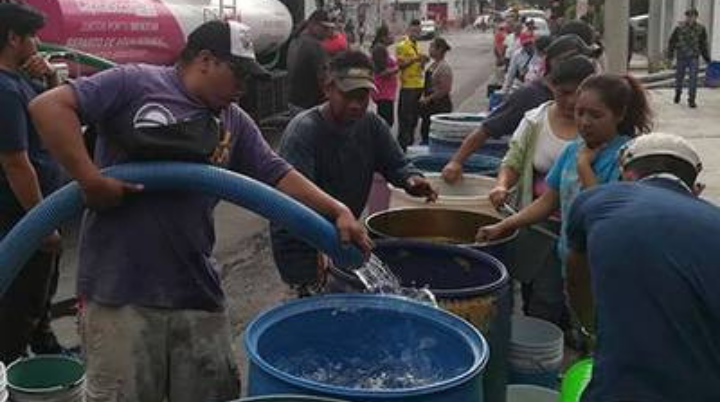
[26,0,292,64]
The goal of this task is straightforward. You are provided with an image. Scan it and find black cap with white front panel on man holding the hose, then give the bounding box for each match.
[186,20,270,79]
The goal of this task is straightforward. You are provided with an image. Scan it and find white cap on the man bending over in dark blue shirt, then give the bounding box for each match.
[620,133,702,172]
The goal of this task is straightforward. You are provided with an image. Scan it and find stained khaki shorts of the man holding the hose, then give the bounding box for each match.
[80,302,240,402]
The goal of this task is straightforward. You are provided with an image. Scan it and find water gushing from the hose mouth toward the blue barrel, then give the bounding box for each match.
[354,254,438,307]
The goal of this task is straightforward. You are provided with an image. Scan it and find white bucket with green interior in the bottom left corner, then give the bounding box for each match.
[7,355,85,402]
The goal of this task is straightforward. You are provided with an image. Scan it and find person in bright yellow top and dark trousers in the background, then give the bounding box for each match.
[395,20,429,151]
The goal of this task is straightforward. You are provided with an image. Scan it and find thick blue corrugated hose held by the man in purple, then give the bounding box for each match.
[0,162,362,296]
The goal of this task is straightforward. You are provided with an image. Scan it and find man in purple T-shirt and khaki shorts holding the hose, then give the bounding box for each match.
[30,21,370,402]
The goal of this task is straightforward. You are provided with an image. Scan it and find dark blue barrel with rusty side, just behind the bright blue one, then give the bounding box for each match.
[329,240,511,402]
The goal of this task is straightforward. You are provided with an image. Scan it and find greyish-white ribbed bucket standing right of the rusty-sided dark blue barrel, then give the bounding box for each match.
[508,315,564,388]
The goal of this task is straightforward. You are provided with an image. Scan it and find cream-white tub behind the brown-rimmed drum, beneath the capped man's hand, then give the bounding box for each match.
[388,173,500,217]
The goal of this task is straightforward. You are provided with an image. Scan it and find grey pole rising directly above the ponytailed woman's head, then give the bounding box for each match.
[603,0,630,74]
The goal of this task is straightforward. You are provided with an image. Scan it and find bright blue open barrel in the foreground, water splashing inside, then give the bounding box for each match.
[245,294,488,402]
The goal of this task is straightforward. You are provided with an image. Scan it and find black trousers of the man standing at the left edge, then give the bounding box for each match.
[0,252,57,364]
